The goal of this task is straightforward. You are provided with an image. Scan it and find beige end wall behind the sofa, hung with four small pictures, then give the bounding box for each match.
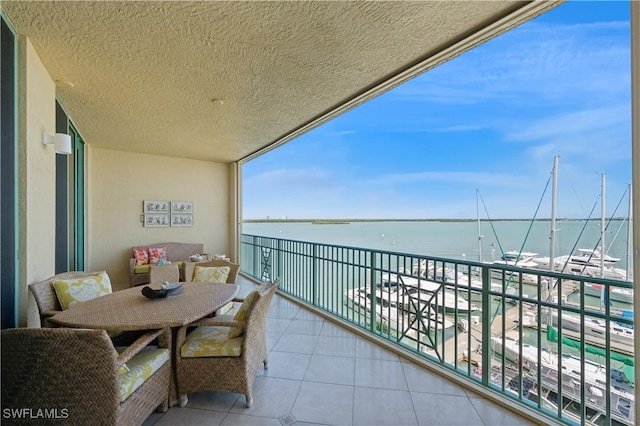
[85,148,230,288]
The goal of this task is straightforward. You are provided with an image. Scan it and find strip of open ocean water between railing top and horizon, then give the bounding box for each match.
[243,219,628,269]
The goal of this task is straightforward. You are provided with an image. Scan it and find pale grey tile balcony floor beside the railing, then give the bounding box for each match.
[144,295,532,426]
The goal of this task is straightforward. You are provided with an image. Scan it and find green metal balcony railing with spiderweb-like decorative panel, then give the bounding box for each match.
[240,234,635,425]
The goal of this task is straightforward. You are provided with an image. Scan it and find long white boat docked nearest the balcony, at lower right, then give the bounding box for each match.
[491,337,635,425]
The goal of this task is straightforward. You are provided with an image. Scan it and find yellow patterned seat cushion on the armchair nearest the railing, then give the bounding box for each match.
[180,326,244,358]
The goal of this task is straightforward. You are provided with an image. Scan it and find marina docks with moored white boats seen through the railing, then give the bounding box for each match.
[345,263,635,425]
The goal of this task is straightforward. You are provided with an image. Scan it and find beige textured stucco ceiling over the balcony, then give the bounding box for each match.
[2,1,551,162]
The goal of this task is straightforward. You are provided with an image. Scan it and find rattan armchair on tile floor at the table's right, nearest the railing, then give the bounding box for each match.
[175,280,278,407]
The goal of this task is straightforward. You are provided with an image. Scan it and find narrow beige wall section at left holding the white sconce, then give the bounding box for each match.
[18,37,55,326]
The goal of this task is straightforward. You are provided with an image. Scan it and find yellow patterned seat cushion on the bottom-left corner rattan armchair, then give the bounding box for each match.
[118,346,170,402]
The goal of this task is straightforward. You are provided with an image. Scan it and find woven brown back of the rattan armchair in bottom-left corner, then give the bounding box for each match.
[1,328,120,424]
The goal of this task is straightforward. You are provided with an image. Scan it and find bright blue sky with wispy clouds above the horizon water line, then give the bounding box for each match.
[243,1,631,219]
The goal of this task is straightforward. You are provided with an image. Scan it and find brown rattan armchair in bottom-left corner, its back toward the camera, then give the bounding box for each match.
[1,328,171,425]
